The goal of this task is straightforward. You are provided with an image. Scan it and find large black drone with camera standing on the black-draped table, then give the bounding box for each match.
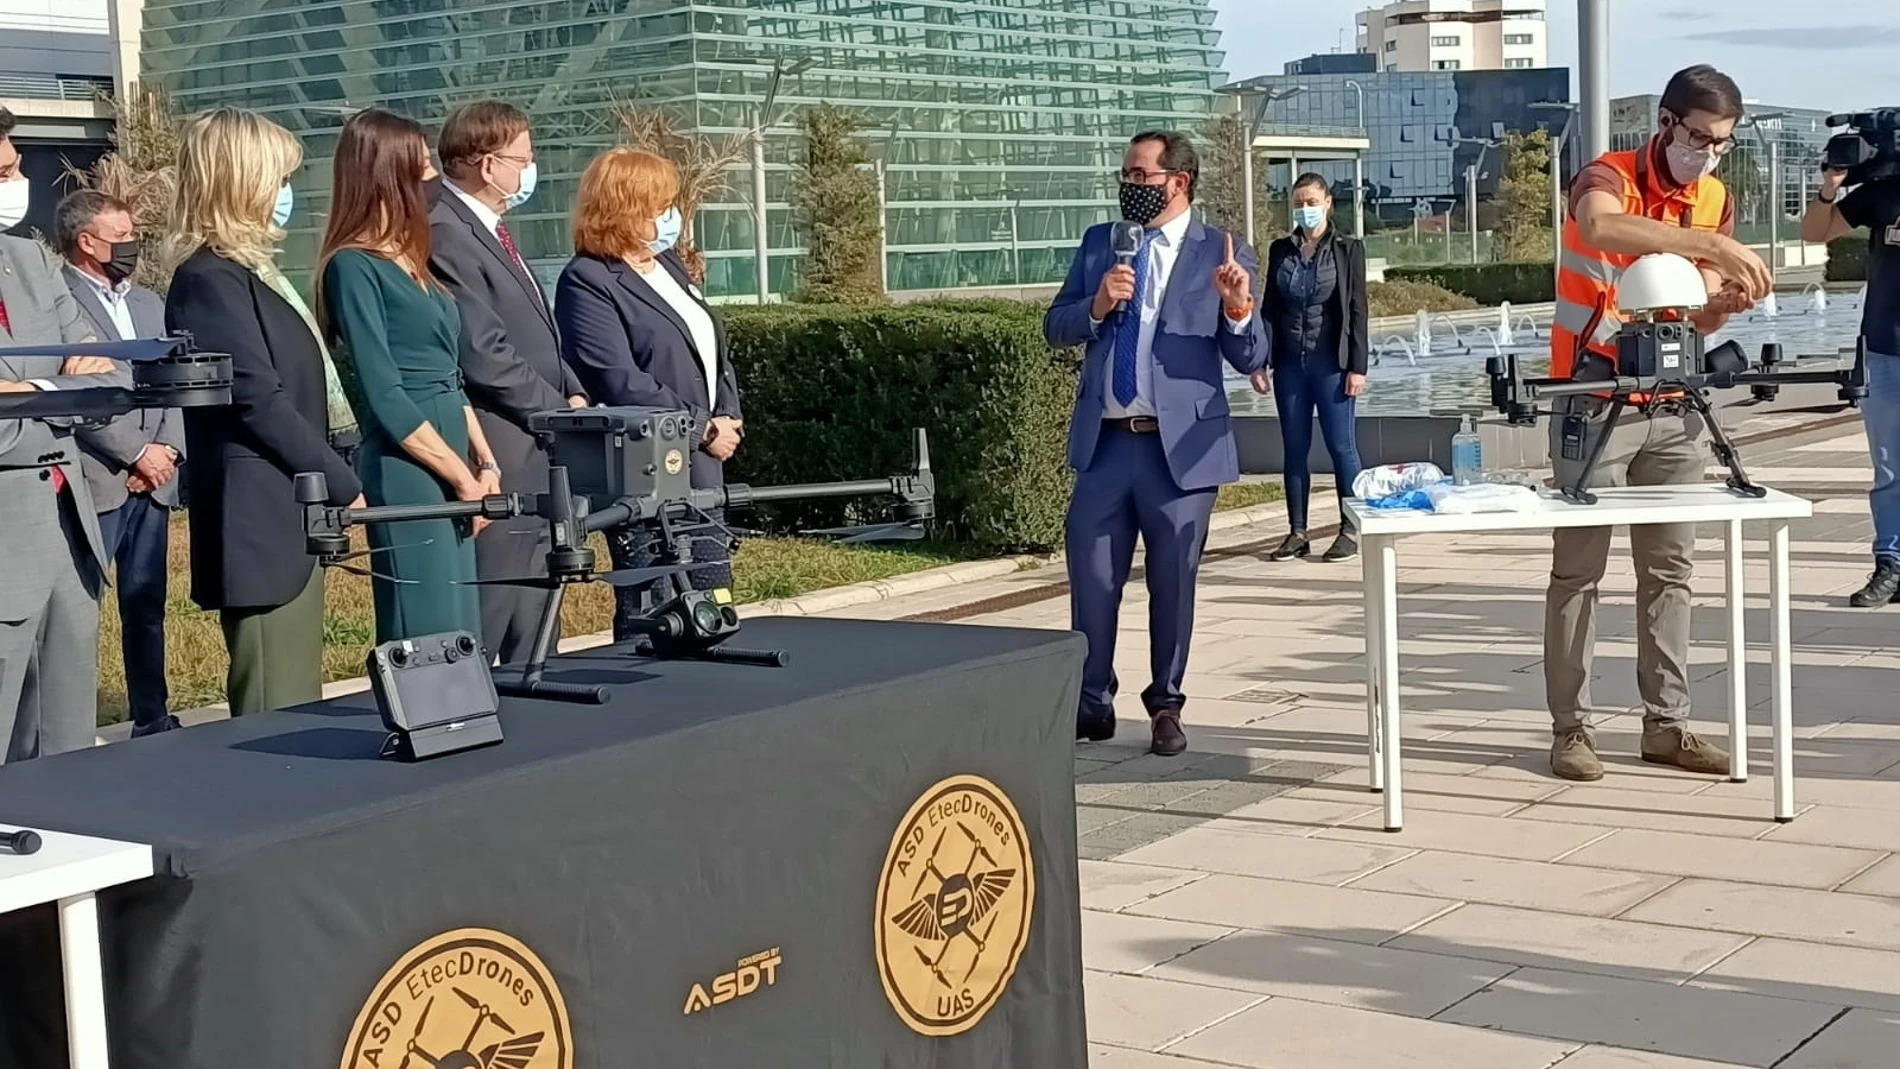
[296,408,937,704]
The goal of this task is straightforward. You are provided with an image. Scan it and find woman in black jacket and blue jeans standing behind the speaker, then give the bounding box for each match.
[1254,175,1368,560]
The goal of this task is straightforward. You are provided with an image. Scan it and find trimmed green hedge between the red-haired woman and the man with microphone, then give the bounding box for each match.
[726,302,1077,549]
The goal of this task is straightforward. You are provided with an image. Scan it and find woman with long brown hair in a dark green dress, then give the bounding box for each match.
[317,108,502,642]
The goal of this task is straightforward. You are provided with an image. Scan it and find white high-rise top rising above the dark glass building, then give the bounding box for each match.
[1359,0,1550,72]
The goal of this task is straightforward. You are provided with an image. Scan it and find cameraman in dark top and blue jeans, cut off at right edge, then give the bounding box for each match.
[1801,161,1900,610]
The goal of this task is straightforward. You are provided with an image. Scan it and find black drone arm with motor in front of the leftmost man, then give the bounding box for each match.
[0,332,232,422]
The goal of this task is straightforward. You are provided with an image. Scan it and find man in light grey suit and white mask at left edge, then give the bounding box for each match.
[0,108,131,761]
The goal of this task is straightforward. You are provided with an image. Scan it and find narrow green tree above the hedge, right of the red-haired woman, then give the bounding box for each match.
[792,104,884,304]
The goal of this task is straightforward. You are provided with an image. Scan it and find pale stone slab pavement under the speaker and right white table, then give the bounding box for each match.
[838,410,1900,1069]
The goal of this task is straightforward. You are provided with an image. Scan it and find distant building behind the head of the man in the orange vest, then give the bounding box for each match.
[1609,93,1839,226]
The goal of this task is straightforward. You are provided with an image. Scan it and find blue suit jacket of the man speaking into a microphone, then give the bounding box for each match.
[1043,220,1271,490]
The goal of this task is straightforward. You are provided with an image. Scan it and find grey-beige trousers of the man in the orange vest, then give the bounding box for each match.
[1545,399,1706,737]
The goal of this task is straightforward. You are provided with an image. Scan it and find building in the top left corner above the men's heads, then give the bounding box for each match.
[0,0,114,234]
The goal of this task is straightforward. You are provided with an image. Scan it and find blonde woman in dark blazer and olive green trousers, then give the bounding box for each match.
[165,108,361,716]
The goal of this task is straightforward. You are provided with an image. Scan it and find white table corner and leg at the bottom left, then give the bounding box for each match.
[0,824,152,1069]
